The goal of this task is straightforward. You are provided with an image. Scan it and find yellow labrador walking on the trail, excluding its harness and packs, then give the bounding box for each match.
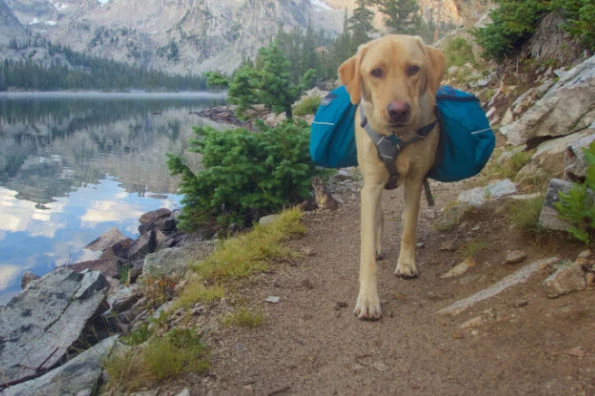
[339,35,445,319]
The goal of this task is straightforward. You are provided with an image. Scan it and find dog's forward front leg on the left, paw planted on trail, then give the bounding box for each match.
[353,183,384,319]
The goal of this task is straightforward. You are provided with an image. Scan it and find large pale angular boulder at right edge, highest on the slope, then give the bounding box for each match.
[500,56,595,146]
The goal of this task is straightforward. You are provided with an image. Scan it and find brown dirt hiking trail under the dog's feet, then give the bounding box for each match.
[186,183,595,395]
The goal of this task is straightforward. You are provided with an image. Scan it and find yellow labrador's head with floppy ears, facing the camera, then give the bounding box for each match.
[339,35,446,138]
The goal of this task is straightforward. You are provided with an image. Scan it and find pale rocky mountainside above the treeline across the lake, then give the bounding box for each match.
[0,0,485,74]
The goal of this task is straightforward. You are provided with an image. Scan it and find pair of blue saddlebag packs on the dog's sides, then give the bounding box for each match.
[310,86,496,182]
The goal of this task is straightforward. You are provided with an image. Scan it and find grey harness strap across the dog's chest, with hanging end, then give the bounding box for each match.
[359,106,438,206]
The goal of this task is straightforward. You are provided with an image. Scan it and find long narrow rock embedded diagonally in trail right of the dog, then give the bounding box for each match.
[438,257,560,315]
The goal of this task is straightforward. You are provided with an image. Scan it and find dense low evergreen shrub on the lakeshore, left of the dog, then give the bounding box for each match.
[168,121,318,231]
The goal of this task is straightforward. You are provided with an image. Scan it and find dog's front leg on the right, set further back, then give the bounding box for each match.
[395,180,423,278]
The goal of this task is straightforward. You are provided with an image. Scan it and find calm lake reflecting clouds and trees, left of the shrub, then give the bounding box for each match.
[0,93,225,304]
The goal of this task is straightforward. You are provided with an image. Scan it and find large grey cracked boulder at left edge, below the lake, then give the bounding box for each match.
[0,267,107,387]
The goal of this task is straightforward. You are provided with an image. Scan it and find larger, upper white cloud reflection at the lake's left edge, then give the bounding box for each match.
[0,187,65,240]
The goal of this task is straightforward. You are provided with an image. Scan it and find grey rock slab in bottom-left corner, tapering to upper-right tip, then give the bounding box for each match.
[2,336,118,396]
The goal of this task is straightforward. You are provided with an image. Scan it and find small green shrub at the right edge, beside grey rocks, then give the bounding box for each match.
[555,142,595,246]
